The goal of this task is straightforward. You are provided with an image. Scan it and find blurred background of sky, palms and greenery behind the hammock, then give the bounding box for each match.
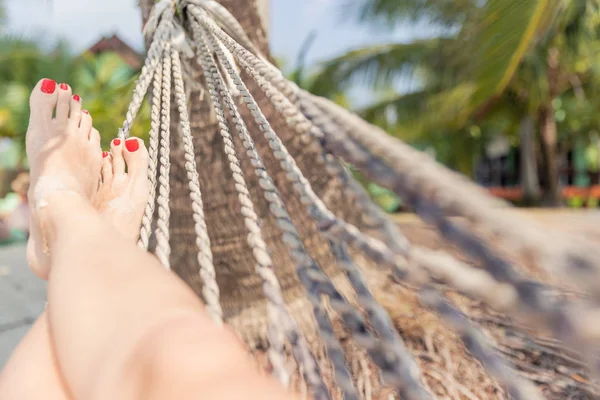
[0,0,600,231]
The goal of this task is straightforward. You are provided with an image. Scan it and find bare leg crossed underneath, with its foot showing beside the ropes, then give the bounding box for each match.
[0,110,148,400]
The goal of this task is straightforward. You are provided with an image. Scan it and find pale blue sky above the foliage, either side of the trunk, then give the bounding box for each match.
[5,0,422,65]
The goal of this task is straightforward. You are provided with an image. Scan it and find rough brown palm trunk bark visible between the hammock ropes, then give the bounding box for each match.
[140,0,366,317]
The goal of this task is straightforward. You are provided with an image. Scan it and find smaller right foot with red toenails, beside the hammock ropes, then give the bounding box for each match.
[94,138,149,240]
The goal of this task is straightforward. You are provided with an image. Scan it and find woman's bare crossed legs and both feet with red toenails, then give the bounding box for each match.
[0,79,293,400]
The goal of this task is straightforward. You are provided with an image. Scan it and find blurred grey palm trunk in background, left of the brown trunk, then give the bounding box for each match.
[519,116,540,205]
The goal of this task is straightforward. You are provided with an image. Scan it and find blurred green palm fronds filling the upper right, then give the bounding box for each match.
[311,0,600,202]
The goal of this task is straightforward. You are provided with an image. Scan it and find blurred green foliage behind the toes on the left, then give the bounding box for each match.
[0,29,149,161]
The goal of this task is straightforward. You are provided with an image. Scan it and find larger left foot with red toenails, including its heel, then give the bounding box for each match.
[27,79,102,279]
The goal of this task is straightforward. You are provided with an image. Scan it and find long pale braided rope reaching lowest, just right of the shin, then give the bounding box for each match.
[194,23,290,387]
